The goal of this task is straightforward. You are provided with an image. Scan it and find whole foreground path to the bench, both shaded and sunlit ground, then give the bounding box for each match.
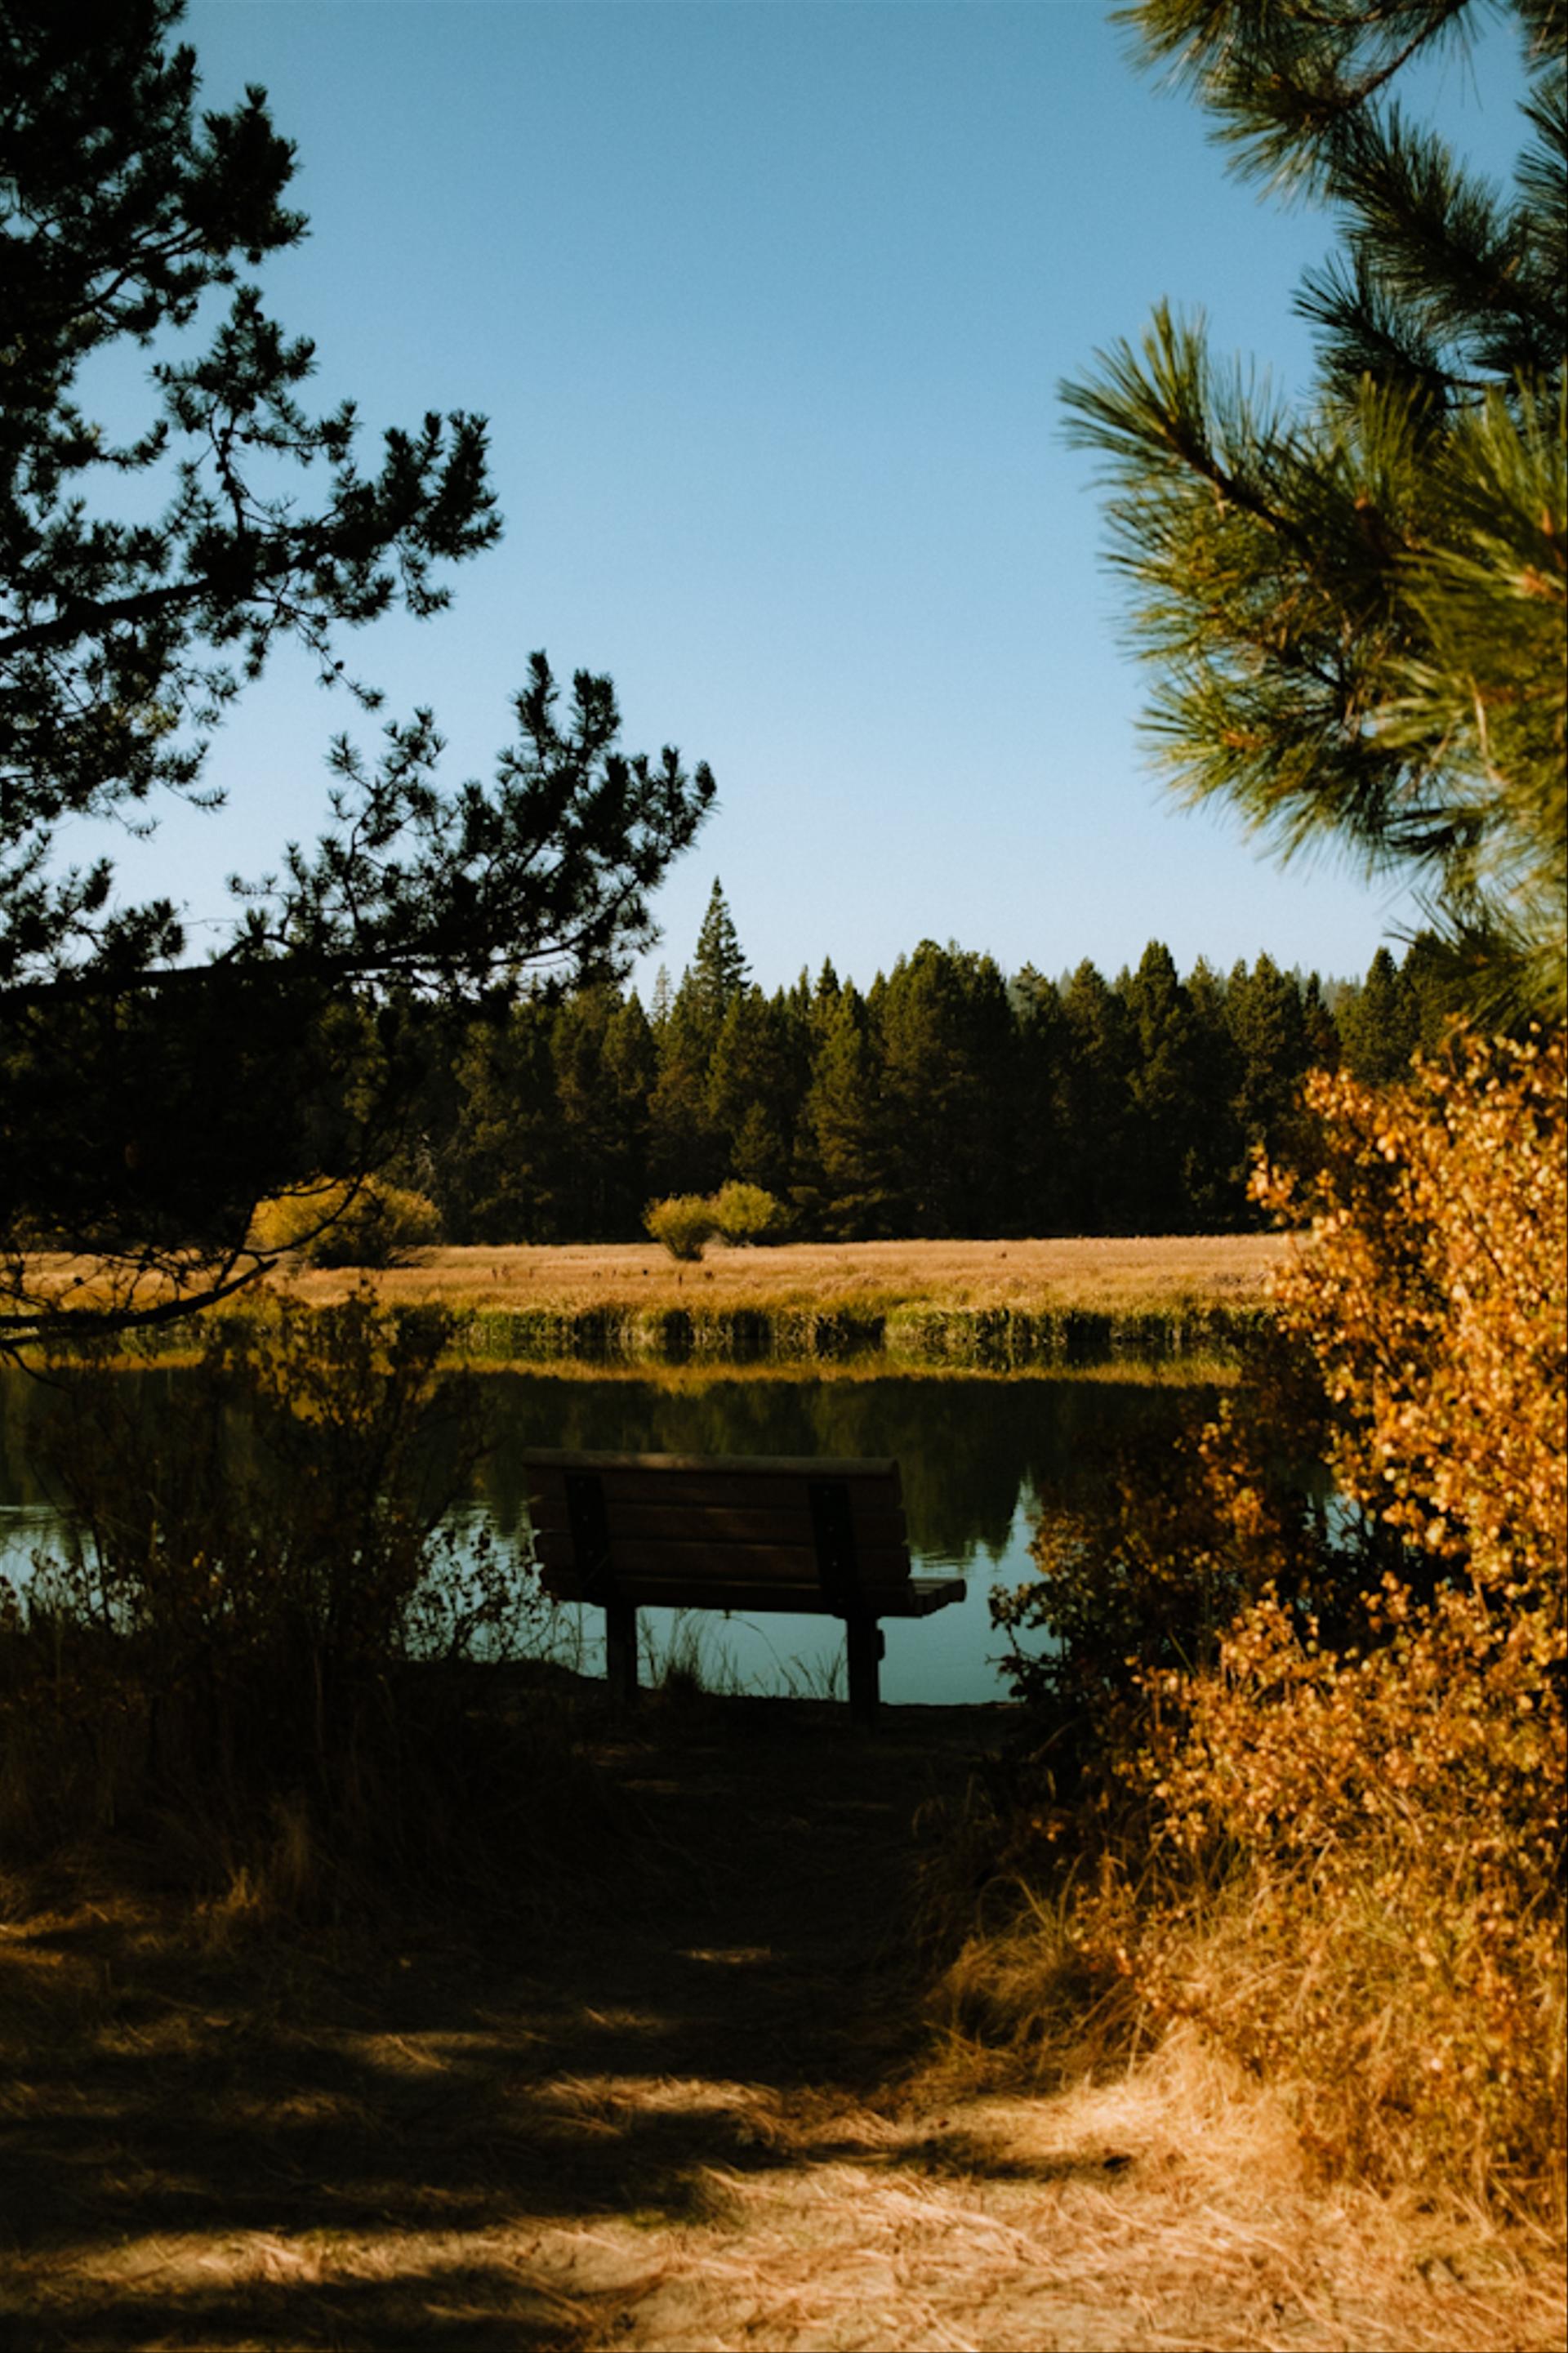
[0,1701,1561,2353]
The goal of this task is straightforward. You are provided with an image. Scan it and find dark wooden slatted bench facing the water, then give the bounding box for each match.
[523,1447,965,1722]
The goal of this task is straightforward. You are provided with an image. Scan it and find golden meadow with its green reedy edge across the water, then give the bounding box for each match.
[33,1233,1290,1379]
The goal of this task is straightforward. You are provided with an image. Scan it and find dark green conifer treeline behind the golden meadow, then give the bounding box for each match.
[403,885,1441,1242]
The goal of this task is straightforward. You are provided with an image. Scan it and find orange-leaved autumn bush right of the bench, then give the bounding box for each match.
[965,1036,1568,2222]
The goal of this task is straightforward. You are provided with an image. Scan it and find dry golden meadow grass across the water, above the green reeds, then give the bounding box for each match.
[278,1233,1290,1313]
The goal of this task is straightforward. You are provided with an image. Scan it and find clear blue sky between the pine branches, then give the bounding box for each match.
[113,0,1514,988]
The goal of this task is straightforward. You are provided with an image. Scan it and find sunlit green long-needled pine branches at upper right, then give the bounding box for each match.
[1064,0,1568,1017]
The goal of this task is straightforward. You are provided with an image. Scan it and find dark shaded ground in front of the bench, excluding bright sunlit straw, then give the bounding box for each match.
[0,1696,1003,2353]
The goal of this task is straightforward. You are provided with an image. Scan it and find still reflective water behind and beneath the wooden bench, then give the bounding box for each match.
[0,1370,1194,1706]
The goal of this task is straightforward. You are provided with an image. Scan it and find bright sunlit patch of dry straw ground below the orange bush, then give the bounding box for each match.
[567,2045,1561,2353]
